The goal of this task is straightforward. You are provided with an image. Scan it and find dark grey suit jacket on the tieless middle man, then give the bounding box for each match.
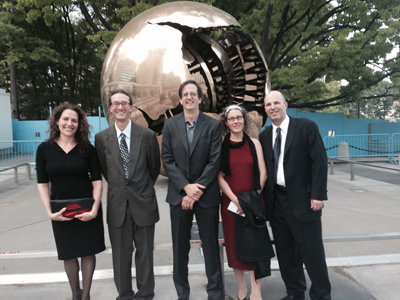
[161,111,222,208]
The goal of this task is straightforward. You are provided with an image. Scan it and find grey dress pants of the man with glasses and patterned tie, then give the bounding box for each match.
[108,201,155,300]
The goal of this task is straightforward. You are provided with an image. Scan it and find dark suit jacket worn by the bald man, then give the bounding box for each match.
[260,117,328,222]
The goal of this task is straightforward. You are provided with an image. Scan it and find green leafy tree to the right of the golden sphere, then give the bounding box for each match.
[239,0,400,109]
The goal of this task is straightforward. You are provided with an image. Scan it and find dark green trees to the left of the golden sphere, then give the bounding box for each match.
[0,0,212,119]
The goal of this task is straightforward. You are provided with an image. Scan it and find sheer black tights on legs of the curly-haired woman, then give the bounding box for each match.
[64,255,96,300]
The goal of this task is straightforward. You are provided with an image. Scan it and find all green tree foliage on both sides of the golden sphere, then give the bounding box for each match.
[0,0,400,118]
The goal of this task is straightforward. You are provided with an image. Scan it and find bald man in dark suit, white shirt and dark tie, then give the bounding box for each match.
[260,91,331,300]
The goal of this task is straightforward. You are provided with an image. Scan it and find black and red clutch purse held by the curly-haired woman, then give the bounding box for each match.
[50,198,94,218]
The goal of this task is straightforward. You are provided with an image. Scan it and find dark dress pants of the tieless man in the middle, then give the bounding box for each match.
[170,202,225,300]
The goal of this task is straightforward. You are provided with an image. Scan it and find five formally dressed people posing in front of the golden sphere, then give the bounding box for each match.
[36,80,331,300]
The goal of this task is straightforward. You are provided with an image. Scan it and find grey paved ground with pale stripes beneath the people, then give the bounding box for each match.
[0,158,400,300]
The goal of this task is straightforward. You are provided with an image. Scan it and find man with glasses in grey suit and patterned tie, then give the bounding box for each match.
[96,90,161,300]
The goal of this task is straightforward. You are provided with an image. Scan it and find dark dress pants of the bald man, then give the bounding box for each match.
[271,189,331,300]
